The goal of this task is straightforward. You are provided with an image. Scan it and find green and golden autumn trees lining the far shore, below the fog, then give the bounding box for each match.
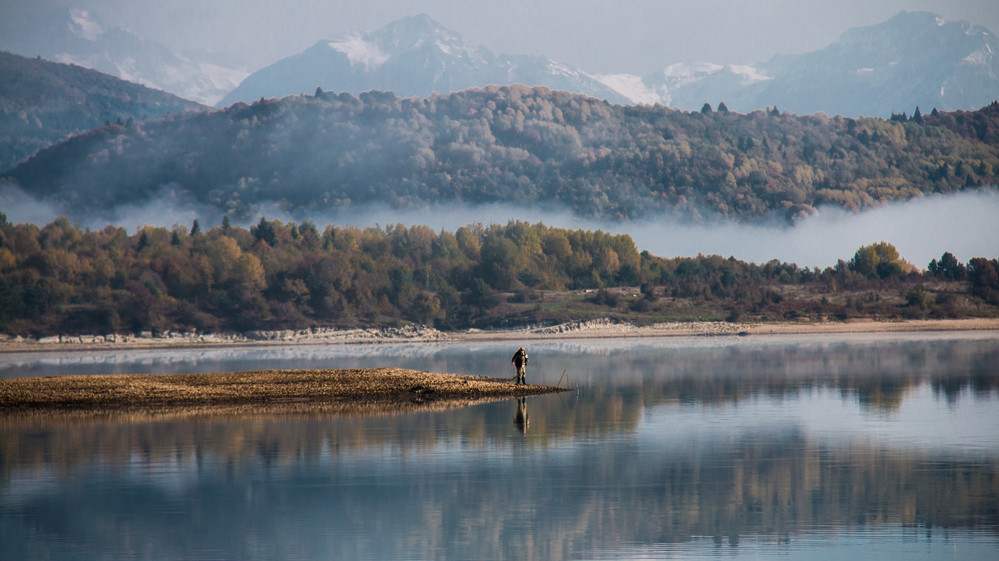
[0,213,999,337]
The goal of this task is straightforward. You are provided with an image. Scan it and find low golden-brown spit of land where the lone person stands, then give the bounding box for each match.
[0,368,569,420]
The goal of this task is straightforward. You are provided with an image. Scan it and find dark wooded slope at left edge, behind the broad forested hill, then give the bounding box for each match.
[0,52,203,170]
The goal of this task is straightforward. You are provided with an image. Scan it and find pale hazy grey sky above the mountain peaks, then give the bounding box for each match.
[0,0,999,75]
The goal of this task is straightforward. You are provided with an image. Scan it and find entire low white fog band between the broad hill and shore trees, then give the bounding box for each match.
[0,185,999,269]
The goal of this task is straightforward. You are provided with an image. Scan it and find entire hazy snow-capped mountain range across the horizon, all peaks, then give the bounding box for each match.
[0,8,999,117]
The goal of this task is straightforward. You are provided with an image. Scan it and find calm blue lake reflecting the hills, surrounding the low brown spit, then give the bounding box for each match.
[0,333,999,561]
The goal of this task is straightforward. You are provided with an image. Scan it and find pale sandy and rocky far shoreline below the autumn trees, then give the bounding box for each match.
[0,318,999,354]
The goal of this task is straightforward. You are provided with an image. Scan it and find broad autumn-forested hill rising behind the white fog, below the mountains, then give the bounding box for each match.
[8,86,999,219]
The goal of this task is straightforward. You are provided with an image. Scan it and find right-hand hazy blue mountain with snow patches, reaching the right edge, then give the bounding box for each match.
[602,12,999,117]
